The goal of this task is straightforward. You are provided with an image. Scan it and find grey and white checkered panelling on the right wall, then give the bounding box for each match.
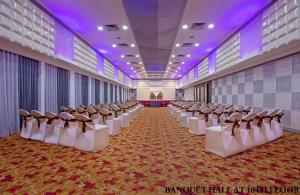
[212,53,300,130]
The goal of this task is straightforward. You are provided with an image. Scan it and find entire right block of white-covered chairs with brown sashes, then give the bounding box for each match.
[169,102,284,157]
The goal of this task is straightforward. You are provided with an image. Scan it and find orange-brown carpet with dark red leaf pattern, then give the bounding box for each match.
[0,108,300,195]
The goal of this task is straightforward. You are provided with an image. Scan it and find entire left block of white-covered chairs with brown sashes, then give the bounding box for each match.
[20,102,143,151]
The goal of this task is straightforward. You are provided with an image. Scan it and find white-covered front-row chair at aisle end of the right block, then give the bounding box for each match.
[205,113,244,158]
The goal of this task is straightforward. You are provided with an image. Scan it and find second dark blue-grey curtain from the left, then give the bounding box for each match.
[57,68,70,110]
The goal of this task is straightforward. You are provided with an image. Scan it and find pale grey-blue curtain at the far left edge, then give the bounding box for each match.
[0,50,20,137]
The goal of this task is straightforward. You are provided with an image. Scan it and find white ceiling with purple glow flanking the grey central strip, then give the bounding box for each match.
[36,0,270,79]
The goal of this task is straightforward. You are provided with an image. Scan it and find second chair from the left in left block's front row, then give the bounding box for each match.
[30,110,47,141]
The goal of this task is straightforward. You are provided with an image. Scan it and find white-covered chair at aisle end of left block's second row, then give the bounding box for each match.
[99,108,121,135]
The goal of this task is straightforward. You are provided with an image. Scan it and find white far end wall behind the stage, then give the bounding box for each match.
[135,80,176,100]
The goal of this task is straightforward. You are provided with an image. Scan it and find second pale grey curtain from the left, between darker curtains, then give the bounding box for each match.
[44,64,58,113]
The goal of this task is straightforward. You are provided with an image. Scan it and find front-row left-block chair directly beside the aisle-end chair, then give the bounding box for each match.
[58,112,79,147]
